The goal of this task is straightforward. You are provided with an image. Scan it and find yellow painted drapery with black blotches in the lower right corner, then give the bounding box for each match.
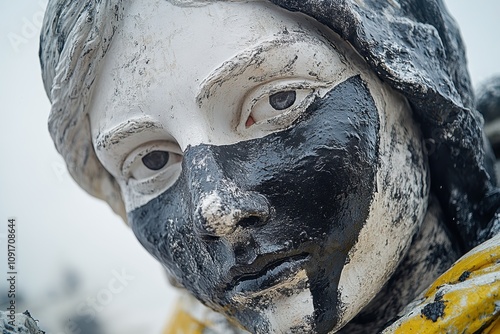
[383,235,500,334]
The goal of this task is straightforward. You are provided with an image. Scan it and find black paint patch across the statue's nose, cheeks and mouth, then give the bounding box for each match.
[129,77,379,333]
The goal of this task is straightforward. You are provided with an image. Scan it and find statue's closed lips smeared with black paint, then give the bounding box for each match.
[233,253,309,294]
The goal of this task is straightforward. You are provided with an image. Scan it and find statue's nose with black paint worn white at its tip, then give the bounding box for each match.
[183,145,269,237]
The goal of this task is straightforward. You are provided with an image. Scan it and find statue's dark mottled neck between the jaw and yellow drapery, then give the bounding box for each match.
[339,197,460,334]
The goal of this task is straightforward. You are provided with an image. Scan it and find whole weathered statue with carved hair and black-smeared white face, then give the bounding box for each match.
[40,0,500,333]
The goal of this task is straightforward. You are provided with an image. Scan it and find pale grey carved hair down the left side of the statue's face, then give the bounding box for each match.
[40,0,126,219]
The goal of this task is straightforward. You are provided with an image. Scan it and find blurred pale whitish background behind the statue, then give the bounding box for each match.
[0,0,500,334]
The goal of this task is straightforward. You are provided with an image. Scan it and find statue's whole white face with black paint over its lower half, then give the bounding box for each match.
[89,0,428,333]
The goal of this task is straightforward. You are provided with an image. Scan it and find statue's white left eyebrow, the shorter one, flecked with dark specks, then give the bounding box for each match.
[95,117,163,151]
